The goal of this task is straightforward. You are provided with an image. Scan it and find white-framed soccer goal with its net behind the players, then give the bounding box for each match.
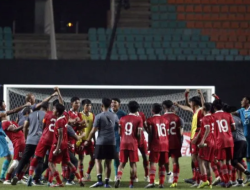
[4,85,215,156]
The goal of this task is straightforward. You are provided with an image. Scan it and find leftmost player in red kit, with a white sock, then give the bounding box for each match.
[2,119,25,185]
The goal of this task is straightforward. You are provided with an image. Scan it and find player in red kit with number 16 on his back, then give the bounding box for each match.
[145,103,169,188]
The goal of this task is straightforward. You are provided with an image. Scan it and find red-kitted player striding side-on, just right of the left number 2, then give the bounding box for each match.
[49,104,84,187]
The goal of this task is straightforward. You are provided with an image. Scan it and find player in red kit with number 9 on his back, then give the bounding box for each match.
[115,101,143,188]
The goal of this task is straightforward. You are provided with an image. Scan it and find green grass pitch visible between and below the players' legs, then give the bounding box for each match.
[0,157,221,190]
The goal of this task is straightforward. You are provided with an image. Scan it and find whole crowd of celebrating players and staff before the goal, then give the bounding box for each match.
[0,87,250,188]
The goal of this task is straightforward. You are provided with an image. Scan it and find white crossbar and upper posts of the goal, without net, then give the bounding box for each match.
[3,84,215,109]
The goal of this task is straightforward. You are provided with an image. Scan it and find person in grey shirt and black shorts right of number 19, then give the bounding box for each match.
[223,105,250,187]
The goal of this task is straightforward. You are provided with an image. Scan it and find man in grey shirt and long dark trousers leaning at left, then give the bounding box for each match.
[11,102,48,185]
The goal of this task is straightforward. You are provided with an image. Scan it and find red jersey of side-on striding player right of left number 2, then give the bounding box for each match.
[53,115,68,150]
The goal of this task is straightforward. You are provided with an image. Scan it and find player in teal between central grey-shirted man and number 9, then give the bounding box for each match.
[110,98,127,181]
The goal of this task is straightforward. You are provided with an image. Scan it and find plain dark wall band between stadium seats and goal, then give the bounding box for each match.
[0,60,247,107]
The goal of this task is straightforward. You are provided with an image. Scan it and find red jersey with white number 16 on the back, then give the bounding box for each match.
[147,114,169,152]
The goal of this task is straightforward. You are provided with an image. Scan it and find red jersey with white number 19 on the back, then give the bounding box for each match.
[213,110,234,149]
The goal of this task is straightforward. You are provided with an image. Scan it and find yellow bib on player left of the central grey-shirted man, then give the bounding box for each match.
[76,112,95,146]
